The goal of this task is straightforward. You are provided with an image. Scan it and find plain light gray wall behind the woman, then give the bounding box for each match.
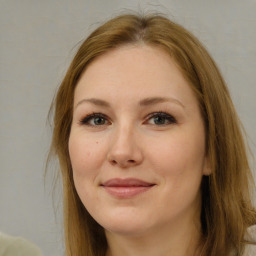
[0,0,256,256]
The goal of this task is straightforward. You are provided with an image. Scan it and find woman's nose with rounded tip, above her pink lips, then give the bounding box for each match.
[107,124,143,168]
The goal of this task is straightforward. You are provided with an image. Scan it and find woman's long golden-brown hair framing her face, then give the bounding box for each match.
[50,14,256,256]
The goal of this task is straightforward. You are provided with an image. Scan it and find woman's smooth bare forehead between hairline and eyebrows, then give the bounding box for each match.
[74,45,195,107]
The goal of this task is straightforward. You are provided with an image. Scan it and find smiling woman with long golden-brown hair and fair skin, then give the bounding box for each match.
[48,15,256,256]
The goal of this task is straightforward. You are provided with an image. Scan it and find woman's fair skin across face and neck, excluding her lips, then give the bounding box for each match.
[69,45,209,255]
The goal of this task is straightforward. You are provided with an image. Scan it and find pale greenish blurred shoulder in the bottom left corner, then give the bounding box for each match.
[0,233,42,256]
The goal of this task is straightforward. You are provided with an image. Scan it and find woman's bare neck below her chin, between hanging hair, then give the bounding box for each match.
[106,215,201,256]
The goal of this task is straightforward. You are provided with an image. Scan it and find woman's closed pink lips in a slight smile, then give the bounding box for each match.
[101,178,155,199]
